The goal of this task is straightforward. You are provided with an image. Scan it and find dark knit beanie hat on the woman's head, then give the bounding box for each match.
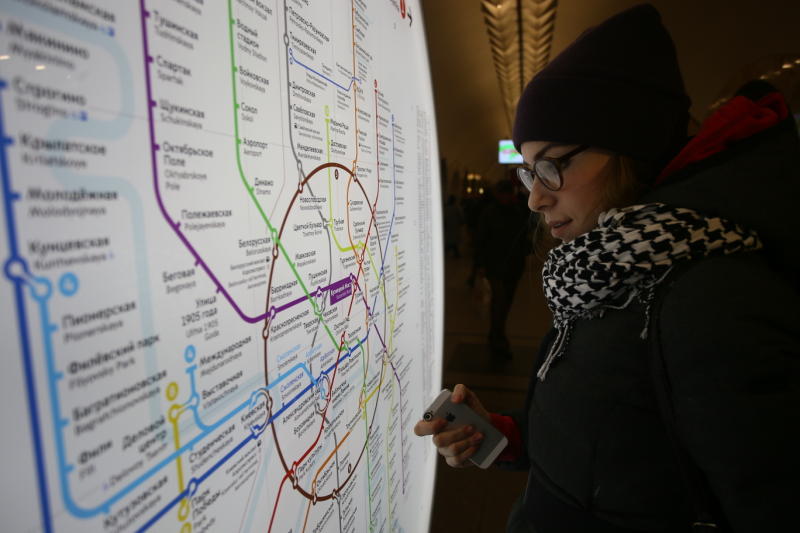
[513,4,691,168]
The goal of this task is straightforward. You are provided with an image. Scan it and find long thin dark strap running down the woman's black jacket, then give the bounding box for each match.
[648,268,727,533]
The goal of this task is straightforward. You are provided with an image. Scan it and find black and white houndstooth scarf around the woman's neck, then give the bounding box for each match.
[536,203,761,381]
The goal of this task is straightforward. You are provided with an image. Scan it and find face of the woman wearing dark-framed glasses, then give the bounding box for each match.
[521,141,611,242]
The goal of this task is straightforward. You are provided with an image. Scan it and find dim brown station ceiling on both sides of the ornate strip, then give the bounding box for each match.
[422,0,800,187]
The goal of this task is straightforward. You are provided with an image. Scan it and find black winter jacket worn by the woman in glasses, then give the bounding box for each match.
[501,87,800,533]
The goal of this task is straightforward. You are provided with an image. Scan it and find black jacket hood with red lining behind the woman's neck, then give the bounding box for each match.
[639,82,800,286]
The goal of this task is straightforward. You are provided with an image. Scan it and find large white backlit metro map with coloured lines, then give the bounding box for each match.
[0,0,442,533]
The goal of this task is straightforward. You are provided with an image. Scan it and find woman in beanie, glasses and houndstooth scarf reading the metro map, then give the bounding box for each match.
[415,5,800,533]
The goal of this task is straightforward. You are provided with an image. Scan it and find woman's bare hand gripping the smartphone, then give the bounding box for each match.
[414,384,491,468]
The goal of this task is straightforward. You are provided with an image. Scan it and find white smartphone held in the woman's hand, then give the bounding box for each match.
[422,389,508,468]
